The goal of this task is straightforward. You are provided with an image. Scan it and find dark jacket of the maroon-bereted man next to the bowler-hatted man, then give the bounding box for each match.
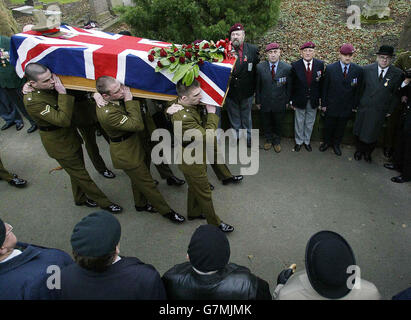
[322,61,362,118]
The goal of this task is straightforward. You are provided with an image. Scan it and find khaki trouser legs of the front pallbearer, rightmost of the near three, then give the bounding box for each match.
[180,164,221,226]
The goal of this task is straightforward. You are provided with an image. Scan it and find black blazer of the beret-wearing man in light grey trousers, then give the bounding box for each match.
[291,59,324,109]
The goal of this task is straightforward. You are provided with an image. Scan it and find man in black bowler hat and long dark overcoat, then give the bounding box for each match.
[354,45,402,163]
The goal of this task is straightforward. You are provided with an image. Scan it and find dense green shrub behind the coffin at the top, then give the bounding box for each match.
[117,0,281,43]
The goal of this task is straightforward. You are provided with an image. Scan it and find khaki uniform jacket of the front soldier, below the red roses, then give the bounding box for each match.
[172,105,219,174]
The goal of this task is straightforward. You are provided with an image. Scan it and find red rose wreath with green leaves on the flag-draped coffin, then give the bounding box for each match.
[148,39,232,86]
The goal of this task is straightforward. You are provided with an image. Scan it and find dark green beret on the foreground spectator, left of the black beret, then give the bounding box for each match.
[71,211,121,257]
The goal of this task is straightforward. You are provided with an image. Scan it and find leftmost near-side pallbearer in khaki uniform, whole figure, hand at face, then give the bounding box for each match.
[24,63,123,213]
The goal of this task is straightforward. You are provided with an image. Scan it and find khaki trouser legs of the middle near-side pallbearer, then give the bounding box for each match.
[123,164,171,215]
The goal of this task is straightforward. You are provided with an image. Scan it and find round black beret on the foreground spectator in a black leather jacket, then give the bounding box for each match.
[187,224,230,272]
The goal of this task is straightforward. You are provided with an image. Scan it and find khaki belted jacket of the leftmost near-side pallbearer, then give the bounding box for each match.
[24,90,82,159]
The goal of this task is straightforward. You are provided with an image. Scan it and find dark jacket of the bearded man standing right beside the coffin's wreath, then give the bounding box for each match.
[227,42,260,102]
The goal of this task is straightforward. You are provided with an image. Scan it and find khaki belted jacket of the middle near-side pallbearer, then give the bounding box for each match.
[96,100,144,169]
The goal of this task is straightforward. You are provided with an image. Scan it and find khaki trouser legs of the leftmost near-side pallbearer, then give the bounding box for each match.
[56,148,112,208]
